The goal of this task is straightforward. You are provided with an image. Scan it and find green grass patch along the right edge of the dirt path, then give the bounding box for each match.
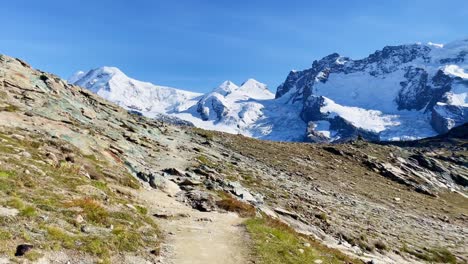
[245,217,362,264]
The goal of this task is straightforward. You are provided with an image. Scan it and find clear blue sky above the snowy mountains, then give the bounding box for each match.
[0,0,468,92]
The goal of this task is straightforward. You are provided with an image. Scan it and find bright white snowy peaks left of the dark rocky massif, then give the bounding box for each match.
[68,67,292,136]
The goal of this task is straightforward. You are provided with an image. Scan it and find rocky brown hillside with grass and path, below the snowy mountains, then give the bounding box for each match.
[0,56,468,263]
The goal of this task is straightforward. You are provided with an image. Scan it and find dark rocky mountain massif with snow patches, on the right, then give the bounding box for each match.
[275,40,468,141]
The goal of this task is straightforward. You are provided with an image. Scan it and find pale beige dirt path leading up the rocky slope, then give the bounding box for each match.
[136,190,249,264]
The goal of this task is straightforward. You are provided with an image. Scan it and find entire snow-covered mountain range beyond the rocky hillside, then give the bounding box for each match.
[69,39,468,142]
